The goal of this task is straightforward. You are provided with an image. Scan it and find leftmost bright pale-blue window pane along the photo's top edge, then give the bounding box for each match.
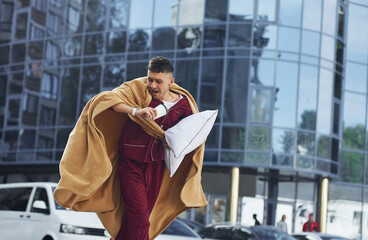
[129,0,153,29]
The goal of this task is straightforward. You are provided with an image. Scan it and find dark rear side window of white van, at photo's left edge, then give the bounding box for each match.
[0,187,32,211]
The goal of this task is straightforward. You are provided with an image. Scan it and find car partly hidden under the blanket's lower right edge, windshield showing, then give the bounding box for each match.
[156,218,202,240]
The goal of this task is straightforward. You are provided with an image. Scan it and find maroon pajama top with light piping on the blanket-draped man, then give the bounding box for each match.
[119,94,192,162]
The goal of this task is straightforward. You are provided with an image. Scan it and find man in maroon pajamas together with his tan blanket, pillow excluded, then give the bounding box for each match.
[54,57,207,240]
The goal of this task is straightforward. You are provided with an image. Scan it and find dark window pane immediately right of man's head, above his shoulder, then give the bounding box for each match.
[175,59,199,99]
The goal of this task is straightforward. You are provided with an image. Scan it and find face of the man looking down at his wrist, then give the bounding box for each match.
[147,70,174,100]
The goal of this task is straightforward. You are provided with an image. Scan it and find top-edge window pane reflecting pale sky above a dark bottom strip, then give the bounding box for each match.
[229,0,254,22]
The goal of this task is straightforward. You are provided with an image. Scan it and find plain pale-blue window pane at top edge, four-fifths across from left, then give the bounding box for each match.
[279,0,302,27]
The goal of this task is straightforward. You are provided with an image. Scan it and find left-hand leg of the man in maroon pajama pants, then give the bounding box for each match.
[116,159,150,240]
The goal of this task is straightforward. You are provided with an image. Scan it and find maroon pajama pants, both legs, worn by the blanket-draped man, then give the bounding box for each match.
[116,158,165,240]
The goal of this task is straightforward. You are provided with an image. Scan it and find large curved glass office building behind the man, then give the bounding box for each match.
[0,0,368,239]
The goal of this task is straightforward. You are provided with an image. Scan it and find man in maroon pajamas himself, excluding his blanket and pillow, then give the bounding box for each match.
[112,57,192,240]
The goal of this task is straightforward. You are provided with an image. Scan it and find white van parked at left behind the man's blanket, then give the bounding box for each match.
[0,182,110,240]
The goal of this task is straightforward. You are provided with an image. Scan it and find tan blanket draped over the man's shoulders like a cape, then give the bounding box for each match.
[54,77,207,239]
